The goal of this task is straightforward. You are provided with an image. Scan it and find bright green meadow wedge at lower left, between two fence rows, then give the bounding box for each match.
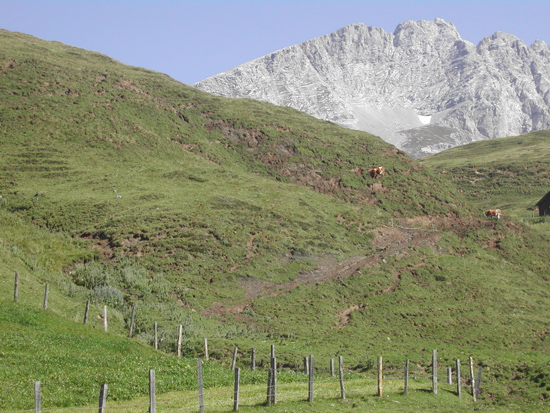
[0,300,282,411]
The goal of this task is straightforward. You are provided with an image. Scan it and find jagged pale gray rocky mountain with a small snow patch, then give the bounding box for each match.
[194,19,550,158]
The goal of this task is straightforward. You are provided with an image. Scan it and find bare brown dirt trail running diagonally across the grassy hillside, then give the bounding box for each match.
[202,219,456,318]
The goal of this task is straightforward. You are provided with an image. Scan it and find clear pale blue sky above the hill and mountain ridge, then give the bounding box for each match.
[0,0,550,84]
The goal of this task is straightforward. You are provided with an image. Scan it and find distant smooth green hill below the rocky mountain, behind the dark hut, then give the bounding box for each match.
[421,131,550,217]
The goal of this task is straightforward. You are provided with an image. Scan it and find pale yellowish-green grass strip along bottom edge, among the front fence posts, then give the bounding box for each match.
[45,375,524,413]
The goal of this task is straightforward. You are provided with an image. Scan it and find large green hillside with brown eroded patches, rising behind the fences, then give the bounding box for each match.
[0,31,550,409]
